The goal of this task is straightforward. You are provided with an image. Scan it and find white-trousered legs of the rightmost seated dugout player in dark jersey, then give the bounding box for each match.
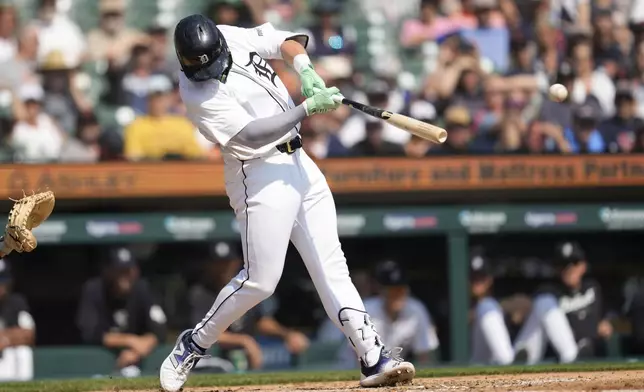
[514,294,577,364]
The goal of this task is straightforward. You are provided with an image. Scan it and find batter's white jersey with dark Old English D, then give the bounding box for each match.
[179,23,308,160]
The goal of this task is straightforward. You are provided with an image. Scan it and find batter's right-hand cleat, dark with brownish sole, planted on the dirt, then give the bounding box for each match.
[360,347,416,388]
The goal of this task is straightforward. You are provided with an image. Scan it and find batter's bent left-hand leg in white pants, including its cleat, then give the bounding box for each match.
[161,160,301,392]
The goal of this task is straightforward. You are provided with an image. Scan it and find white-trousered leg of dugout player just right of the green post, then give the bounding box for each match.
[472,297,514,365]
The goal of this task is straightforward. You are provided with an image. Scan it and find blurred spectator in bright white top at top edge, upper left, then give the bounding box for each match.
[30,0,86,69]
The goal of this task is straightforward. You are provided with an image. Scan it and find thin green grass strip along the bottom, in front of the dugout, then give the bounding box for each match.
[5,362,644,392]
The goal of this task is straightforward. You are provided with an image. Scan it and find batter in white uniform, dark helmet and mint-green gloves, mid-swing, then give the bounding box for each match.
[160,15,415,392]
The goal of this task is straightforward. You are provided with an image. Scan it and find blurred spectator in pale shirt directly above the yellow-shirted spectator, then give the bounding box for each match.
[121,45,158,114]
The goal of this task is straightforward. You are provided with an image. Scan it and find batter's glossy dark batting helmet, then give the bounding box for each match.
[174,14,233,82]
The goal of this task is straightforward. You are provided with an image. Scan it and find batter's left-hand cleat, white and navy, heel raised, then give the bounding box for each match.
[159,329,208,392]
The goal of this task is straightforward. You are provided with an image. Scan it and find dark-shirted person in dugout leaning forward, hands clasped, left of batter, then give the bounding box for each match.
[76,248,166,376]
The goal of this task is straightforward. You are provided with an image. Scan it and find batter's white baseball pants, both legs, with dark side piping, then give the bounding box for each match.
[193,149,381,366]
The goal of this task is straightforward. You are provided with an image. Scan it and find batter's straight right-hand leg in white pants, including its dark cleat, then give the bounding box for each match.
[291,152,415,386]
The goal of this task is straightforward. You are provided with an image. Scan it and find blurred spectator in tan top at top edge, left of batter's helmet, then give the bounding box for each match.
[87,0,146,67]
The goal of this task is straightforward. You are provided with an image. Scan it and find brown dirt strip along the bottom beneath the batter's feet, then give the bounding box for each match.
[109,370,644,392]
